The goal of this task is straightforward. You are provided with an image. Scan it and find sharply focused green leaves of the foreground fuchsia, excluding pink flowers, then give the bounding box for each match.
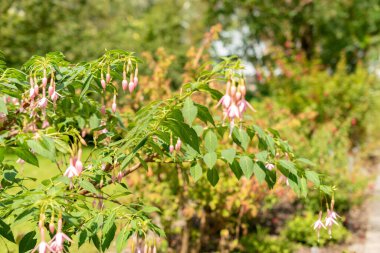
[0,50,332,251]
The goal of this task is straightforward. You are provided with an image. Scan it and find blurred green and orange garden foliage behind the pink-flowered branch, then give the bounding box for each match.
[0,0,380,253]
